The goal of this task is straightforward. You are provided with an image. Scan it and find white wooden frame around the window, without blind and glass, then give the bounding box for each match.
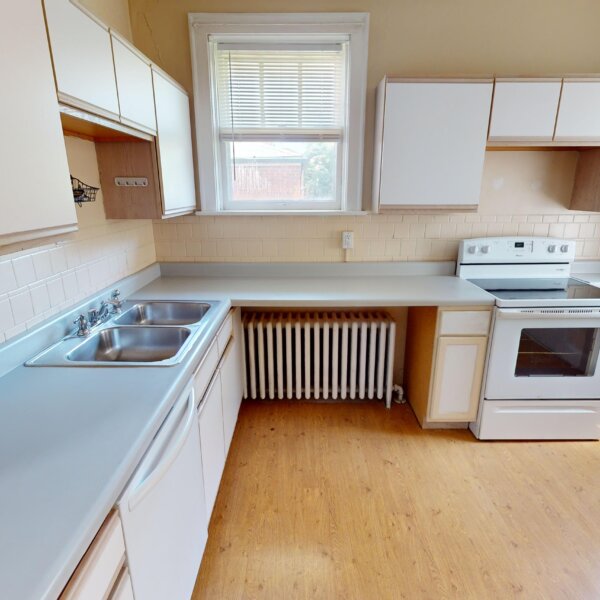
[188,13,369,214]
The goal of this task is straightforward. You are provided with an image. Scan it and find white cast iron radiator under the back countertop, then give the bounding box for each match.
[243,312,396,408]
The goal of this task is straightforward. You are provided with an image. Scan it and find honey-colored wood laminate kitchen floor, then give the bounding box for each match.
[193,402,600,600]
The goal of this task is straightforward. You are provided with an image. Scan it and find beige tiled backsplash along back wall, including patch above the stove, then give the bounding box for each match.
[154,152,600,262]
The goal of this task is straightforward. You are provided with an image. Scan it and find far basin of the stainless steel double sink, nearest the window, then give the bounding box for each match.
[115,302,211,325]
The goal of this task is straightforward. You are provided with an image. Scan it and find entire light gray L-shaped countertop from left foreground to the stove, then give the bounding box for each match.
[0,269,494,600]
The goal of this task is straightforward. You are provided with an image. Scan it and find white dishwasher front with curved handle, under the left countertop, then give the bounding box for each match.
[118,384,208,600]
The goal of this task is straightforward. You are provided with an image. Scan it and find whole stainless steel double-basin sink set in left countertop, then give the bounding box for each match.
[26,301,219,367]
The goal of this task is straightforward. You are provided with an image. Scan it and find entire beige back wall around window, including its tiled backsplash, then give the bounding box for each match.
[129,0,600,261]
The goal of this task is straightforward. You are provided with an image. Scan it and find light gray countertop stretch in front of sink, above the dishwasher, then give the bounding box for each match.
[0,297,230,600]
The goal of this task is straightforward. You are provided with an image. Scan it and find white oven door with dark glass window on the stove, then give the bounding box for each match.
[485,308,600,400]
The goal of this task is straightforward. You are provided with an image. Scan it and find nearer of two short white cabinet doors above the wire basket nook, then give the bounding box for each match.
[44,0,119,119]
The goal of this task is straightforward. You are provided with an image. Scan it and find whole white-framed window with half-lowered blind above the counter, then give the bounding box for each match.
[190,13,368,212]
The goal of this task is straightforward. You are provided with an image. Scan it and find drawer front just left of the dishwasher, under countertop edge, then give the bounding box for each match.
[61,512,125,600]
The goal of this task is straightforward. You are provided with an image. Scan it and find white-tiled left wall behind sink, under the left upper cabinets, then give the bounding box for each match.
[0,137,156,343]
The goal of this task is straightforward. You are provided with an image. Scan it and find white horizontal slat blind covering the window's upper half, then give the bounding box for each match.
[215,43,346,140]
